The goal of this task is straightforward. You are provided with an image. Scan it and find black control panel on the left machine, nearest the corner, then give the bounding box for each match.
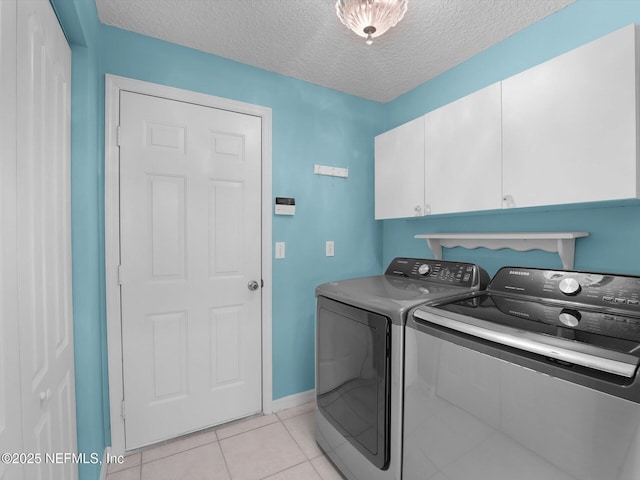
[385,257,489,290]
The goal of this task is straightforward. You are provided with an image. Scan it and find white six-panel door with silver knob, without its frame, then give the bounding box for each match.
[120,91,262,450]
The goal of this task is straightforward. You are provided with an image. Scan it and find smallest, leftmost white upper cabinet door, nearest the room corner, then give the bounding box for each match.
[375,117,424,220]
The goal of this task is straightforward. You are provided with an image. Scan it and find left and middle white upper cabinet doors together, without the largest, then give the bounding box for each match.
[375,83,502,219]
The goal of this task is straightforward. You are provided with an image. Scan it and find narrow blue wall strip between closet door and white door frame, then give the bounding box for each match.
[53,0,110,480]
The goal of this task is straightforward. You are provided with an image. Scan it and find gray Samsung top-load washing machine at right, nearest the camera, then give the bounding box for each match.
[402,267,640,480]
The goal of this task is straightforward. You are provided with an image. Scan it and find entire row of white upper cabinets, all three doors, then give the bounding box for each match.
[376,25,640,218]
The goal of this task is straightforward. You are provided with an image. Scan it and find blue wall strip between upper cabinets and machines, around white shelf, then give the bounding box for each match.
[383,201,640,275]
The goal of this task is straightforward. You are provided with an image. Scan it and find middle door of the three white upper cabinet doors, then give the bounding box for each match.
[425,83,502,214]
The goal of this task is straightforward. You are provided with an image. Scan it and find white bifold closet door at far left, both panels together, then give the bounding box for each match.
[0,0,77,480]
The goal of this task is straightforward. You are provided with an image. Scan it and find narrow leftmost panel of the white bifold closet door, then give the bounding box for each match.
[0,0,24,480]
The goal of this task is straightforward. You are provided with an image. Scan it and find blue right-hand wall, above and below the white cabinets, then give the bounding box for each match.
[382,0,640,274]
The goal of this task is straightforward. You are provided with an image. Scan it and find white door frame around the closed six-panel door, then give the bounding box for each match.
[104,74,273,455]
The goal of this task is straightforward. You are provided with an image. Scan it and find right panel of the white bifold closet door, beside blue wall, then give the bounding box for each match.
[17,0,77,479]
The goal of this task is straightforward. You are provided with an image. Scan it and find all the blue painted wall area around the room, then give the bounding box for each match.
[52,0,640,480]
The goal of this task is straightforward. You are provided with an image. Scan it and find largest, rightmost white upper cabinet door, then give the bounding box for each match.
[502,25,638,207]
